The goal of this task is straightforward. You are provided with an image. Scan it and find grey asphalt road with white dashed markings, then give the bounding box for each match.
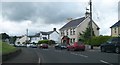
[3,47,119,65]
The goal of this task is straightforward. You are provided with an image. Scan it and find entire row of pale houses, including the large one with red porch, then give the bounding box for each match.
[16,13,100,44]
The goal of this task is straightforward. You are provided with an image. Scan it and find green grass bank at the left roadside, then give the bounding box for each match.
[0,41,16,54]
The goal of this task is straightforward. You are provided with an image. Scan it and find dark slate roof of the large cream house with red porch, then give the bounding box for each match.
[60,17,85,30]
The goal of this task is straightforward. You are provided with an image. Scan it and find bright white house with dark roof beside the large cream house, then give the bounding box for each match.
[31,28,60,43]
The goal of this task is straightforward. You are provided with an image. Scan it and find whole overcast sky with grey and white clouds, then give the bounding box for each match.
[0,0,119,35]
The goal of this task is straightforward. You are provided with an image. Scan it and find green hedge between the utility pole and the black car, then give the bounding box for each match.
[85,36,111,46]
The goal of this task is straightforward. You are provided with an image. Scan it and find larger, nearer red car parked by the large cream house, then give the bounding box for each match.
[67,42,85,51]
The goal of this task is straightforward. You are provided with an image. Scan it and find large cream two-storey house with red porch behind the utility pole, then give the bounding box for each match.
[59,12,99,44]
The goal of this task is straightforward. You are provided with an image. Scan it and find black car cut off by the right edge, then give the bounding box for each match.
[100,37,120,53]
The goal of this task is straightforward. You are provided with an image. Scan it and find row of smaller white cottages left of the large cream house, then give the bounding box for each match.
[15,28,60,44]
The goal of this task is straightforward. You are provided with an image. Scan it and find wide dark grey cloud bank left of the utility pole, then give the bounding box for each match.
[2,2,85,24]
